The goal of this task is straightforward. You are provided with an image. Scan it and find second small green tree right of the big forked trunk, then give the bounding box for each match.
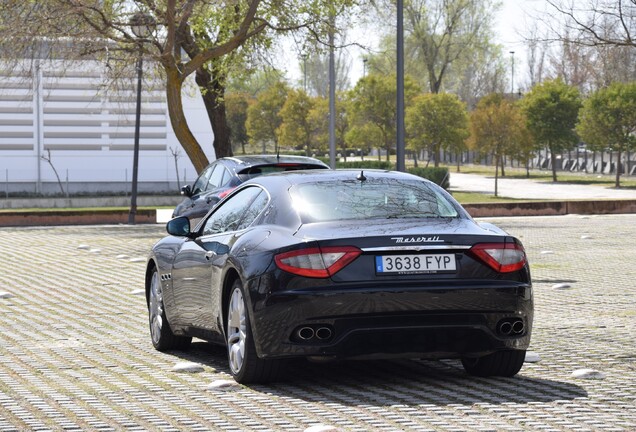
[246,82,289,153]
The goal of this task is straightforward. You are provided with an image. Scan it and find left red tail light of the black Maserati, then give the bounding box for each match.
[274,246,362,278]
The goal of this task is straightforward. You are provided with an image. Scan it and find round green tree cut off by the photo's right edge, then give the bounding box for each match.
[576,82,636,187]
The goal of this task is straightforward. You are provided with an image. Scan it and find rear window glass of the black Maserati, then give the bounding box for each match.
[290,177,458,223]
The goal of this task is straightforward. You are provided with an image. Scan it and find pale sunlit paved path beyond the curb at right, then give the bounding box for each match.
[450,172,636,200]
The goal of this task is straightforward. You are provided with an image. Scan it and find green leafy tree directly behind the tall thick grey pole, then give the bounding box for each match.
[349,74,419,160]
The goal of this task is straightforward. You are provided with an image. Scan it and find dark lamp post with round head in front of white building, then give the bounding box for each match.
[128,12,155,225]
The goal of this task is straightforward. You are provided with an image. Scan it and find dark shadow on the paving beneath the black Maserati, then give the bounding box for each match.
[172,342,588,406]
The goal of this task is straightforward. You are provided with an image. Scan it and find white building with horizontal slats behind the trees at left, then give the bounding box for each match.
[0,60,214,196]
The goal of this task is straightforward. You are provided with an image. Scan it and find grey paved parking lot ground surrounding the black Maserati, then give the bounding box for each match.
[0,215,636,432]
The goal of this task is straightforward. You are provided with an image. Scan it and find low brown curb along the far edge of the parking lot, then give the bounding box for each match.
[0,200,636,227]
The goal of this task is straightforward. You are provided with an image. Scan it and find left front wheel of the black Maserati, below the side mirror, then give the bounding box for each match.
[148,268,192,351]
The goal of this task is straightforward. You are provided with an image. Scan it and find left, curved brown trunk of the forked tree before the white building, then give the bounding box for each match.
[166,68,210,173]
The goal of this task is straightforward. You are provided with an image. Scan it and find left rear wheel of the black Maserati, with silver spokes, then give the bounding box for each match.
[226,280,281,384]
